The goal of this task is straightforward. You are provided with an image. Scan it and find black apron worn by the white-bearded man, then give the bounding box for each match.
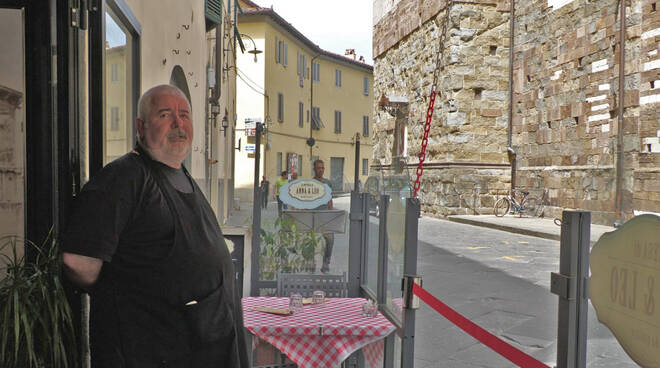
[91,148,248,368]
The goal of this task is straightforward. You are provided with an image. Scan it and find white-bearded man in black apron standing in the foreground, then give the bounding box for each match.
[62,85,248,368]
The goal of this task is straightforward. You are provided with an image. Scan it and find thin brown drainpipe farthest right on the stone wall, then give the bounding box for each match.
[614,0,626,220]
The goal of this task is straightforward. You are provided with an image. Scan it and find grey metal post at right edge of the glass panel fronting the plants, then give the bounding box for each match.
[348,191,364,298]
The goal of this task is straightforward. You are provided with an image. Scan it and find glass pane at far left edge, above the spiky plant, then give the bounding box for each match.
[0,9,26,242]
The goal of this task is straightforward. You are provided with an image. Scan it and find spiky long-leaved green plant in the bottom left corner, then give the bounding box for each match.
[0,230,78,368]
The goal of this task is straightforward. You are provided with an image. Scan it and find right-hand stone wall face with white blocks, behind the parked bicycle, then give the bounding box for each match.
[512,0,660,223]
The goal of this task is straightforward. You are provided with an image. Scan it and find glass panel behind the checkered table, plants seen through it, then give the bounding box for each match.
[258,188,350,297]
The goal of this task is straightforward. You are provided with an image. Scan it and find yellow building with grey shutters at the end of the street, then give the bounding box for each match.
[235,1,373,201]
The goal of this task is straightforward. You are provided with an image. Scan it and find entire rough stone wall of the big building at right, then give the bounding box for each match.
[374,0,660,224]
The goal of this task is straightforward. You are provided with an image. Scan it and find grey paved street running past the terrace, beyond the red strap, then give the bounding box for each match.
[227,197,637,368]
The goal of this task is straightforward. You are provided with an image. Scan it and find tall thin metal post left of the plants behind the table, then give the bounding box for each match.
[250,122,263,296]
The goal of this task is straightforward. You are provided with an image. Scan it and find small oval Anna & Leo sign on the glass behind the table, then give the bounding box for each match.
[280,179,332,209]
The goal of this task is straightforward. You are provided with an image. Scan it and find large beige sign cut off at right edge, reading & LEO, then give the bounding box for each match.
[589,215,660,367]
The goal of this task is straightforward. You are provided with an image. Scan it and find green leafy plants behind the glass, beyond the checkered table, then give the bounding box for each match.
[259,218,323,280]
